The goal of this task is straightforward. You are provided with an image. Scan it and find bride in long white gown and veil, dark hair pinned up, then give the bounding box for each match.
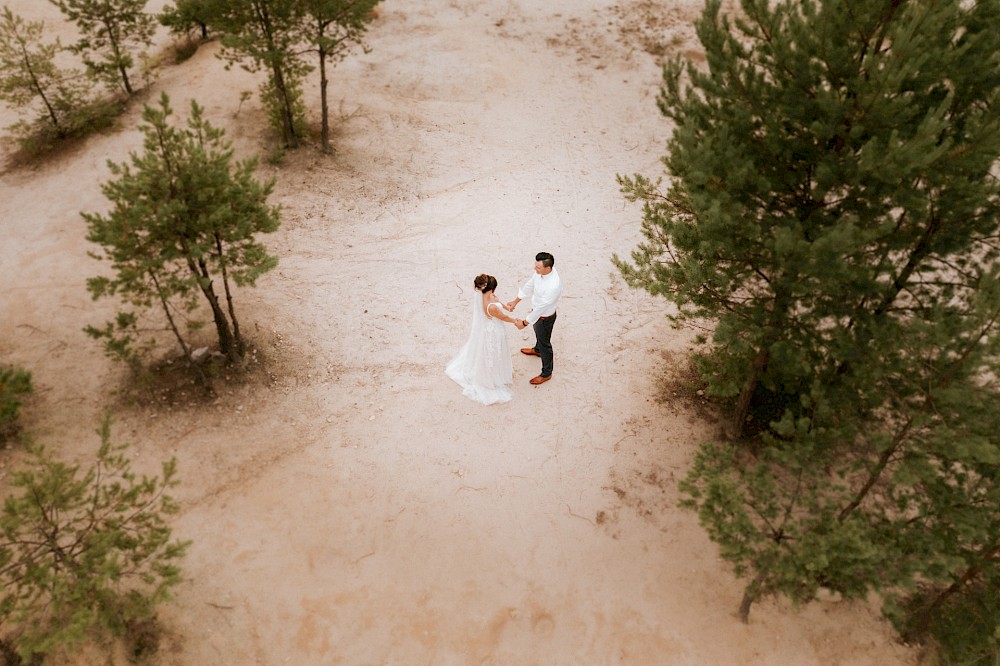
[445,274,527,405]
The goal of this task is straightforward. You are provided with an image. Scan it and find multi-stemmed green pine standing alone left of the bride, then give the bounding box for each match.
[83,94,280,363]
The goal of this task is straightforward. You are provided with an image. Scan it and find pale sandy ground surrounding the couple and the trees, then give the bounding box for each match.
[0,0,916,666]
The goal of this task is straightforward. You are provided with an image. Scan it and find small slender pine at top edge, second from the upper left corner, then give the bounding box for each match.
[49,0,156,96]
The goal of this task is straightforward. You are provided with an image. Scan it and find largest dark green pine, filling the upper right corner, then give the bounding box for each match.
[615,1,1000,434]
